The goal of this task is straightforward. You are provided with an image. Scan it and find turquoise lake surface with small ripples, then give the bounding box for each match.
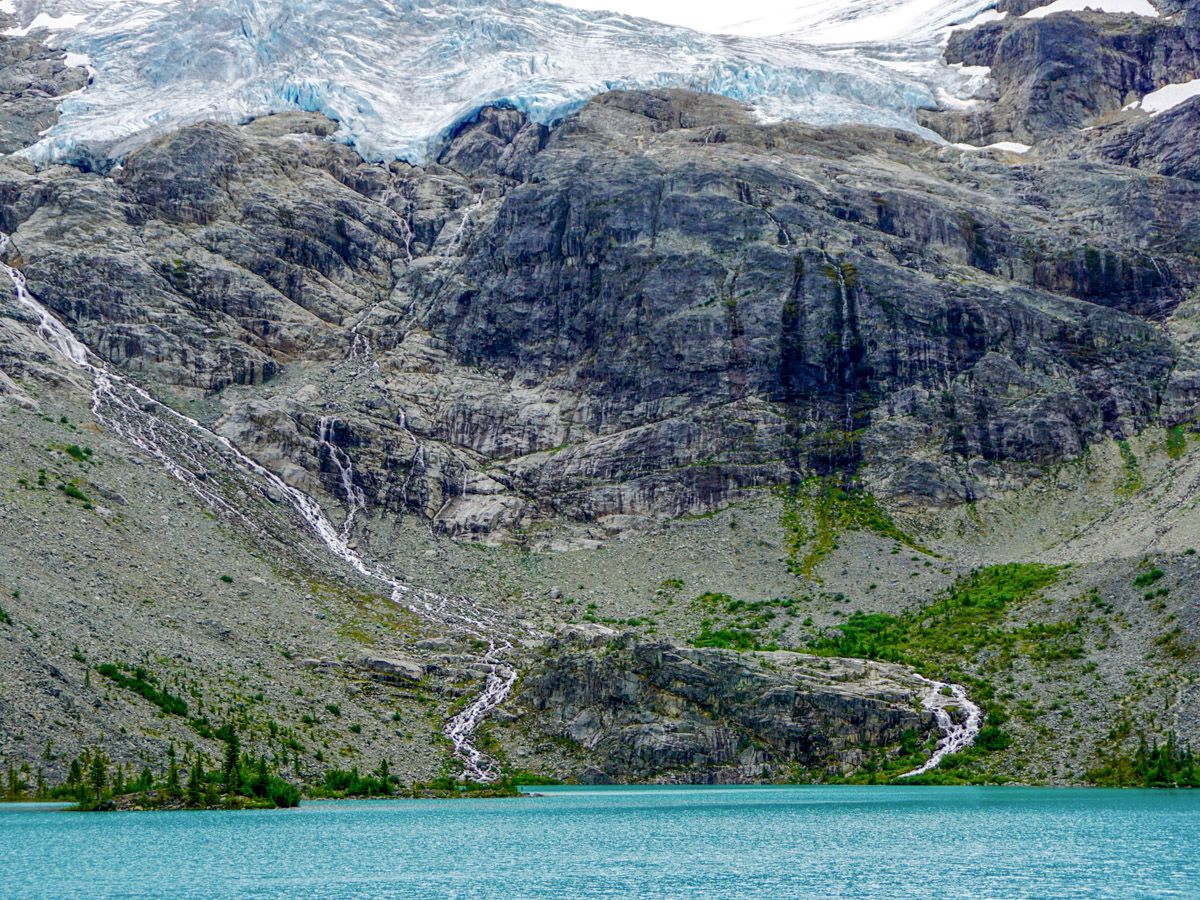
[0,787,1200,900]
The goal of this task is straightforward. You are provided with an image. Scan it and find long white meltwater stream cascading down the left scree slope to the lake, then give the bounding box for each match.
[0,233,517,781]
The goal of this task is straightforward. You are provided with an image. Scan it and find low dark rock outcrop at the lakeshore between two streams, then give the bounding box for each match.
[515,632,936,784]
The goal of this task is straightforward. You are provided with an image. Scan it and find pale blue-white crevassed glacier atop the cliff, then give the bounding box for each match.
[5,0,994,168]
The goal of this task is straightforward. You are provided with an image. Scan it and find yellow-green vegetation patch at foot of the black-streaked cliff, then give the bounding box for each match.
[784,478,931,580]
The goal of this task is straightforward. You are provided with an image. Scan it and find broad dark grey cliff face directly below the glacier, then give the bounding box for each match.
[0,82,1200,536]
